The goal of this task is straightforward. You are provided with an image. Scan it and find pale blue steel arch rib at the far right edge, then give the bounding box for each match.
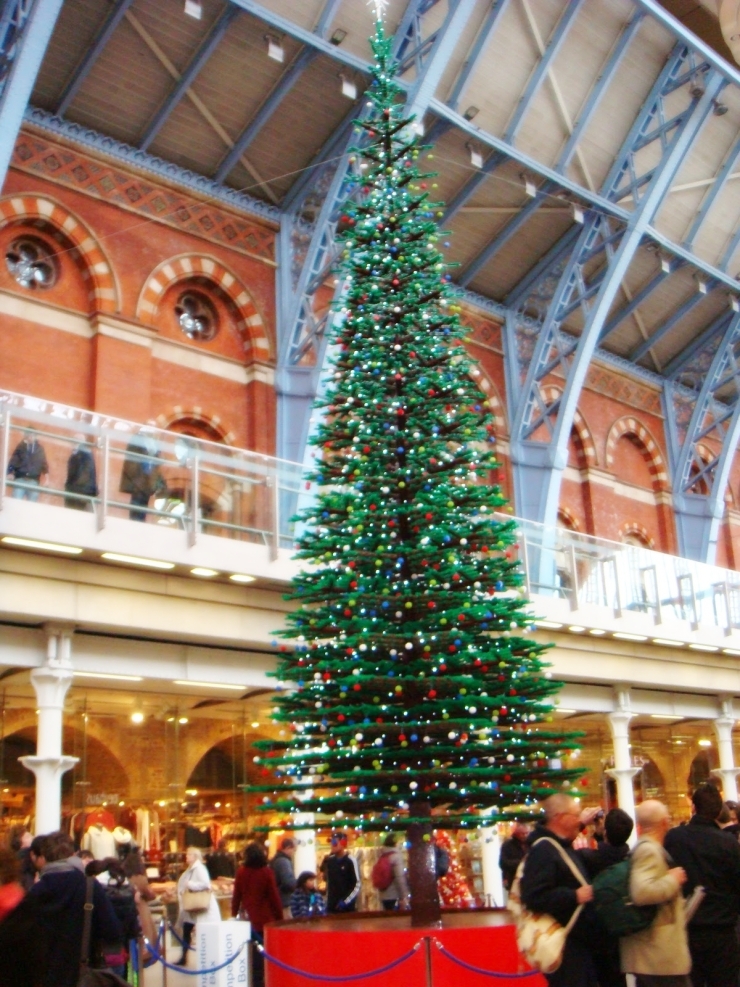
[666,313,740,562]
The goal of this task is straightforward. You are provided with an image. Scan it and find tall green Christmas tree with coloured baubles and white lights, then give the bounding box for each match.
[250,3,577,928]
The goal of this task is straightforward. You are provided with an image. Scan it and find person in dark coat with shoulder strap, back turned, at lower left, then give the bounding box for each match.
[25,833,123,987]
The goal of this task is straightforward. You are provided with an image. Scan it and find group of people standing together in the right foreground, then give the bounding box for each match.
[499,784,740,987]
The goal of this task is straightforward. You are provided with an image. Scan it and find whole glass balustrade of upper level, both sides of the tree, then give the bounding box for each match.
[0,391,740,632]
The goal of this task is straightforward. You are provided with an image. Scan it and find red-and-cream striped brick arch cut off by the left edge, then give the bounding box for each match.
[0,195,120,312]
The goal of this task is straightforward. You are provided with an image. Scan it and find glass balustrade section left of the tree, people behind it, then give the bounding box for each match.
[0,391,305,551]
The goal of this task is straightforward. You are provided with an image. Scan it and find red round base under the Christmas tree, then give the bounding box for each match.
[265,909,545,987]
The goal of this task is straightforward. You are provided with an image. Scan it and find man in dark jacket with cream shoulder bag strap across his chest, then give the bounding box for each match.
[521,794,598,987]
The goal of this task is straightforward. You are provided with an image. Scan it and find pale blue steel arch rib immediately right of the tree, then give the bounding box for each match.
[508,67,723,527]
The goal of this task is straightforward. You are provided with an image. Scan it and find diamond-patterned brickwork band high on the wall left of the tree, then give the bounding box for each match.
[12,131,275,263]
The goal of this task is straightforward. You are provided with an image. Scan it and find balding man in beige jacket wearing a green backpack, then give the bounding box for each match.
[619,799,691,987]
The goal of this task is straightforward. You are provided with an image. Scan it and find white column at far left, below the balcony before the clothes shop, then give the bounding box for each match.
[19,624,79,834]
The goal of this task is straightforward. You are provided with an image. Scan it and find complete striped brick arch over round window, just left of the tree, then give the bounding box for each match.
[136,254,271,361]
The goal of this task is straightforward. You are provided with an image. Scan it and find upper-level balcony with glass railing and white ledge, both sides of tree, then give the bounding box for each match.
[0,391,740,656]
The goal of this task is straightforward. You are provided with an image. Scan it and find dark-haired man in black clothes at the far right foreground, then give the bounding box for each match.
[663,785,740,987]
